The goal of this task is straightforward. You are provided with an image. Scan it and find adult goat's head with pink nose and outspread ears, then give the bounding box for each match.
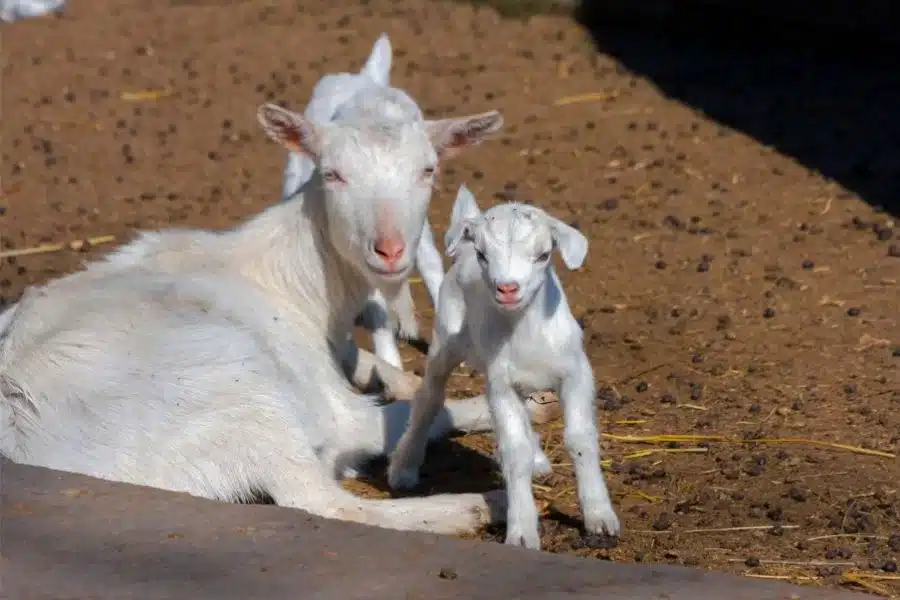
[257,104,503,287]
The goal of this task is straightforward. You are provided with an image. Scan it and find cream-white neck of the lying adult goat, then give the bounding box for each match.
[234,183,372,342]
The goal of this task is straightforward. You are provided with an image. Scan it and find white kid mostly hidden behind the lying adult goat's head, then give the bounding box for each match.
[282,34,444,368]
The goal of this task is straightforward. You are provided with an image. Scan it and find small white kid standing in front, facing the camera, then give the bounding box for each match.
[388,186,619,549]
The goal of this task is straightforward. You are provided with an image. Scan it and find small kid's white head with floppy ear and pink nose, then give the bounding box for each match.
[444,186,588,311]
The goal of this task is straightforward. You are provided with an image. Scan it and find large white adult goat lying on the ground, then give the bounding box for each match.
[0,105,564,533]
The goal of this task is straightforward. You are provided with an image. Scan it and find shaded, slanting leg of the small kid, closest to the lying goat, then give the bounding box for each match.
[388,336,461,490]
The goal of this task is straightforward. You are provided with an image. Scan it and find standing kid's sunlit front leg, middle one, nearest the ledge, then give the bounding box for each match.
[487,380,541,550]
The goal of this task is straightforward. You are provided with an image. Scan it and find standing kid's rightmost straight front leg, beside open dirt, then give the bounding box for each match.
[559,353,619,535]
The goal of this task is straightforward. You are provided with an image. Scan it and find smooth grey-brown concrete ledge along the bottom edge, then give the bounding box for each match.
[0,462,865,600]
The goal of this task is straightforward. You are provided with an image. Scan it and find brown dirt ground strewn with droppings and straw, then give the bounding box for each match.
[0,0,900,595]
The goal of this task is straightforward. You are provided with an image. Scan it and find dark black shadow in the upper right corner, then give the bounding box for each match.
[577,0,900,215]
